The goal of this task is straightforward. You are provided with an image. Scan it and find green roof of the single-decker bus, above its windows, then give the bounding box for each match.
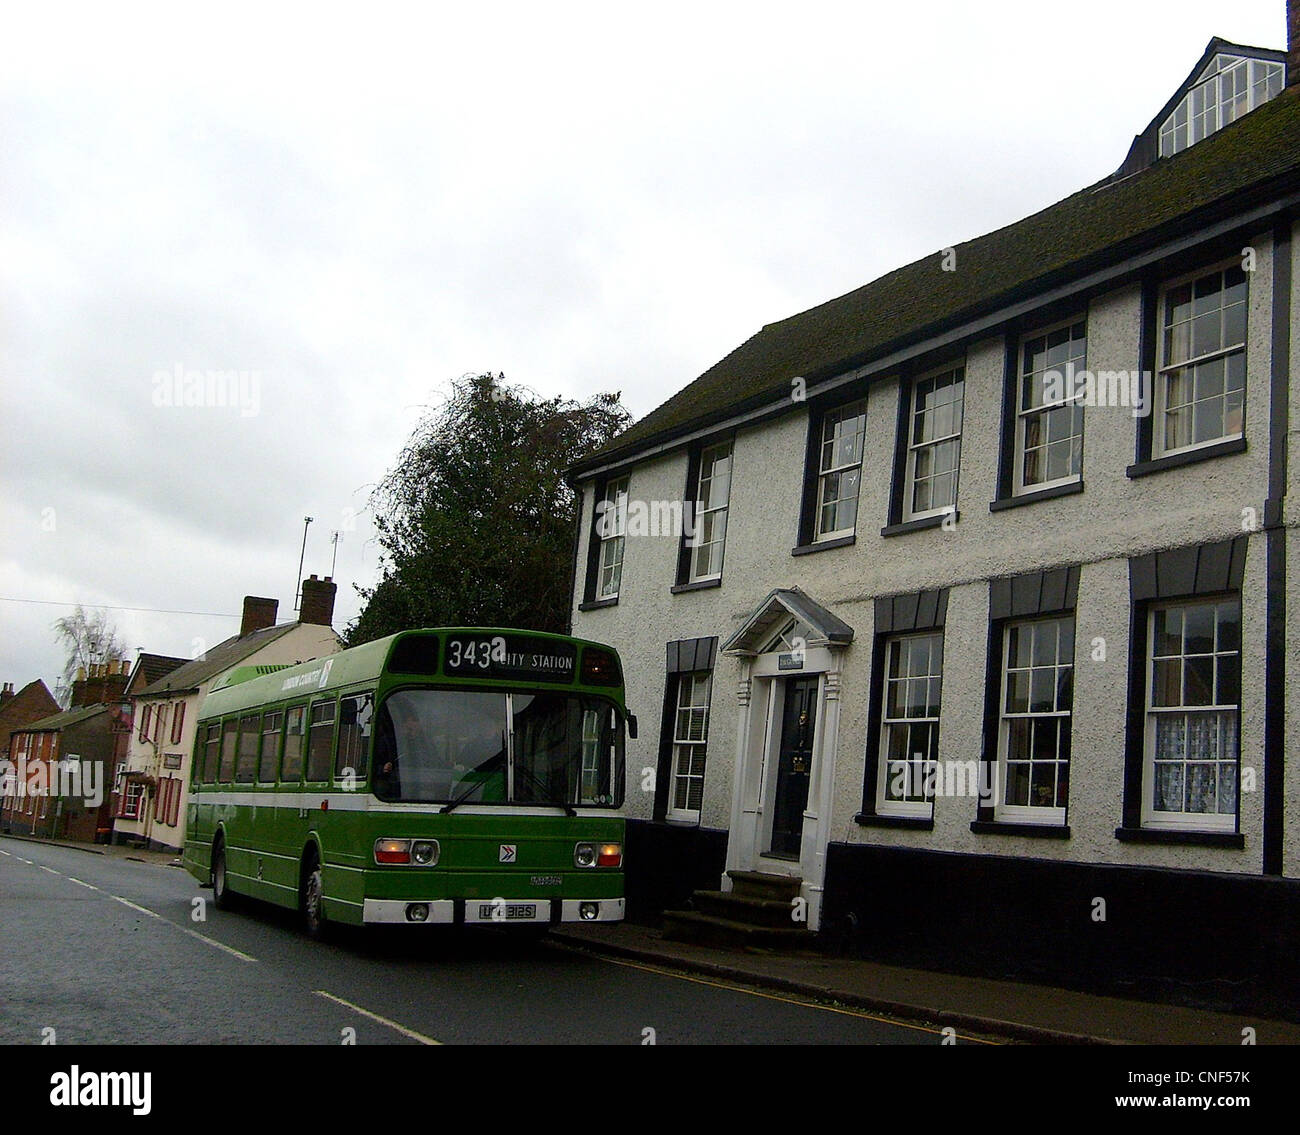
[199,627,621,719]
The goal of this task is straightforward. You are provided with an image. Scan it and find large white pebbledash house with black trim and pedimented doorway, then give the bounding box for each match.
[572,3,1300,992]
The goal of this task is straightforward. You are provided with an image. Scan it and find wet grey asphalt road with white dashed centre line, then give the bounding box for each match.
[0,836,977,1045]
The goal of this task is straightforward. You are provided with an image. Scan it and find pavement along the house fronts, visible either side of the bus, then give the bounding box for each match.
[10,836,1300,1045]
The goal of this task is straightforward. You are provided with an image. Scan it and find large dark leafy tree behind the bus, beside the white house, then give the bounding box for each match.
[347,374,632,646]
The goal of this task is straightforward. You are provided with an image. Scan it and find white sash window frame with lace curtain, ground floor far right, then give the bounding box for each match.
[1141,594,1242,832]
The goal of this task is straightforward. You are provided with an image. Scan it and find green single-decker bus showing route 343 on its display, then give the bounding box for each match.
[183,628,636,937]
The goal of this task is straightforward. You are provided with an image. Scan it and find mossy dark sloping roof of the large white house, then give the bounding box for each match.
[573,87,1300,476]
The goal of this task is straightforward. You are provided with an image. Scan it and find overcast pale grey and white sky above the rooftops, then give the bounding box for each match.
[0,0,1286,685]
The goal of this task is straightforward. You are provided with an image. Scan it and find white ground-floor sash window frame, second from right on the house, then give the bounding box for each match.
[993,612,1078,827]
